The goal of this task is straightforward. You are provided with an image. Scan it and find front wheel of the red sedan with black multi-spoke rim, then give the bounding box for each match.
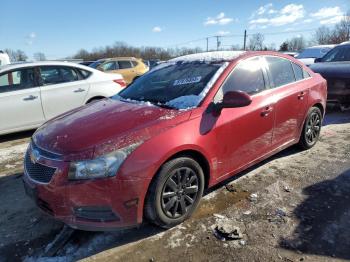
[144,157,204,228]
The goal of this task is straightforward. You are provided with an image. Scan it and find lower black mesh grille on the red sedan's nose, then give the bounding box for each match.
[24,151,56,183]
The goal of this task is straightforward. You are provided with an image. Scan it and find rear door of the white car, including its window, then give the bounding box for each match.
[40,66,90,120]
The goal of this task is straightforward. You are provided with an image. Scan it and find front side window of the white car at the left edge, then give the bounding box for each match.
[0,68,35,93]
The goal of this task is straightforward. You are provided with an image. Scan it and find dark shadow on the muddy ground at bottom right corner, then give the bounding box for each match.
[280,169,350,260]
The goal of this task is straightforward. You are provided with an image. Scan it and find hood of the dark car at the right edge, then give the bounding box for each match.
[310,62,350,78]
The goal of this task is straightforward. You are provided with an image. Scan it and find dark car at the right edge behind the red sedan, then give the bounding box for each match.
[310,42,350,110]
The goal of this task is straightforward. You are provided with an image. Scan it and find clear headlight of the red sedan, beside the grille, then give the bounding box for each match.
[68,143,141,180]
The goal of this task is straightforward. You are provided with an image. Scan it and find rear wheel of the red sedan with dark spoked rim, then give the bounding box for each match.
[299,107,322,150]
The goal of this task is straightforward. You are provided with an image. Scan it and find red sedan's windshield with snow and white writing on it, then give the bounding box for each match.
[114,62,223,109]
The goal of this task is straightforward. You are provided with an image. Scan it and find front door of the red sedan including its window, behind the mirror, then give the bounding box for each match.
[214,57,275,176]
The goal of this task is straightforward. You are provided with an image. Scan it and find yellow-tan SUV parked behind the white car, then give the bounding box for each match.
[89,57,149,85]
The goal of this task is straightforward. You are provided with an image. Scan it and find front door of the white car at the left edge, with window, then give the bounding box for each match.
[0,68,45,133]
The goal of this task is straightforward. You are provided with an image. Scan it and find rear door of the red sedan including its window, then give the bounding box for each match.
[265,56,308,148]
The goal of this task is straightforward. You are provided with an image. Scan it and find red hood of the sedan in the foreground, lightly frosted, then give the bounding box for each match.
[33,99,191,160]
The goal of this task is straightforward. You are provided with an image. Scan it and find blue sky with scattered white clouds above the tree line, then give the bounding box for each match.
[0,0,350,59]
